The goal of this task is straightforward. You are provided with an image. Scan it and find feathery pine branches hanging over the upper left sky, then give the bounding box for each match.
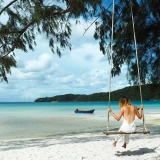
[0,0,101,82]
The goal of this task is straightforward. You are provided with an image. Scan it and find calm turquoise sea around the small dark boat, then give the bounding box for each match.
[0,101,160,140]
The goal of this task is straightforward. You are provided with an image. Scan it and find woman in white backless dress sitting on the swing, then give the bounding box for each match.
[108,97,143,148]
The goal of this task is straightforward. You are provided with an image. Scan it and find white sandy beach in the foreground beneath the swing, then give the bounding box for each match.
[0,133,160,160]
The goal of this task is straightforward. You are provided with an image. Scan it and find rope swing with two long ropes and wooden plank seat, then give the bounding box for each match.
[106,0,150,134]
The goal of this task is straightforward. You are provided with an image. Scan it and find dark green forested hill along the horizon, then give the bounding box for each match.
[35,84,160,102]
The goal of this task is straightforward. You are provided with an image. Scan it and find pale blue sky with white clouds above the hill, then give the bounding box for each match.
[0,2,128,102]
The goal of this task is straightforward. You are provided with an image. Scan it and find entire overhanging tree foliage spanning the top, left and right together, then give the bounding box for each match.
[0,0,160,84]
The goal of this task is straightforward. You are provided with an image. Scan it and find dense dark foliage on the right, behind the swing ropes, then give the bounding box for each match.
[94,0,160,84]
